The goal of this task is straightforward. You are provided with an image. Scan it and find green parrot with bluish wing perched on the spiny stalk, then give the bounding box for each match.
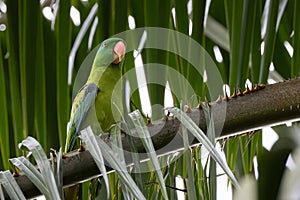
[64,38,126,153]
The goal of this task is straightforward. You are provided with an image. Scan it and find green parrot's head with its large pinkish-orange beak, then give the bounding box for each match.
[94,38,126,66]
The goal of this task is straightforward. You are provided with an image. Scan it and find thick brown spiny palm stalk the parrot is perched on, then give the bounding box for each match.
[2,78,300,198]
